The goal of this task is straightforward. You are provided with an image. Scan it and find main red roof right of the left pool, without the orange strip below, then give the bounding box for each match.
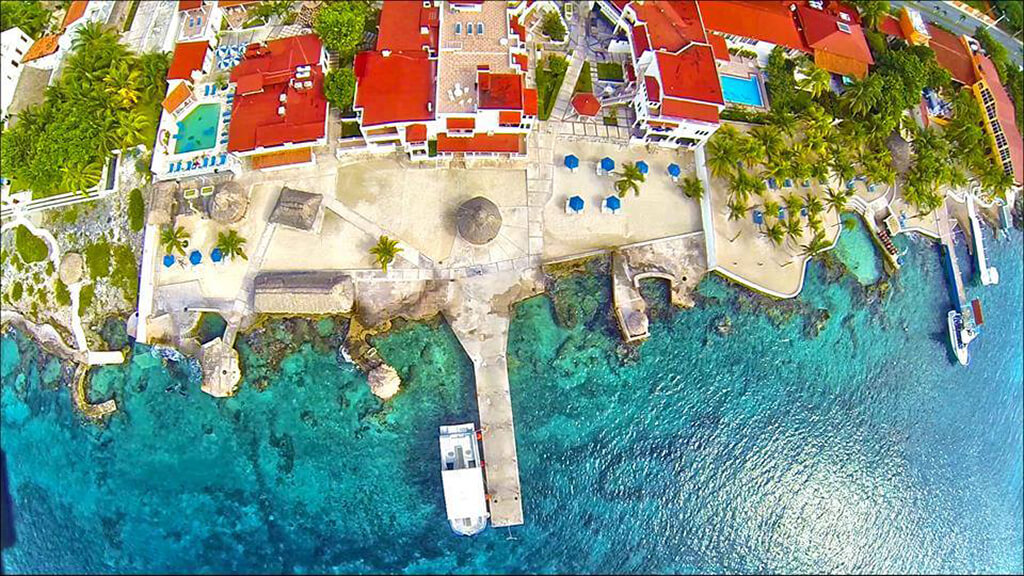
[227,34,327,152]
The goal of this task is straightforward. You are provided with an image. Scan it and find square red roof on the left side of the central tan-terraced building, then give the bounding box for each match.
[354,50,435,126]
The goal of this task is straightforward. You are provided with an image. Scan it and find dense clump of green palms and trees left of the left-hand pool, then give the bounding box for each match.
[0,22,169,196]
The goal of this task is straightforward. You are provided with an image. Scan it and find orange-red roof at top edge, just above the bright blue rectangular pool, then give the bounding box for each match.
[699,0,811,52]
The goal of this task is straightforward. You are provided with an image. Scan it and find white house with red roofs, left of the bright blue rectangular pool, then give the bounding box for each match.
[602,0,725,148]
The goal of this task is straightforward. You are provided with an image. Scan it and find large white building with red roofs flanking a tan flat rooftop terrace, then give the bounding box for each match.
[353,0,548,159]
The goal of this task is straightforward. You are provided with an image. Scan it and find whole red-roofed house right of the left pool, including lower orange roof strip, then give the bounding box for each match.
[227,34,328,168]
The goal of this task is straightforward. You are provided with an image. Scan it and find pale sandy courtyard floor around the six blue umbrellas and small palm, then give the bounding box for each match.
[544,140,700,260]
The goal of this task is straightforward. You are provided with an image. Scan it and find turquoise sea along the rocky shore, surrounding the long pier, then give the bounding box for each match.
[0,227,1024,573]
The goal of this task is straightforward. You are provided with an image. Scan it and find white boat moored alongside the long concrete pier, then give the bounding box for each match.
[438,422,490,536]
